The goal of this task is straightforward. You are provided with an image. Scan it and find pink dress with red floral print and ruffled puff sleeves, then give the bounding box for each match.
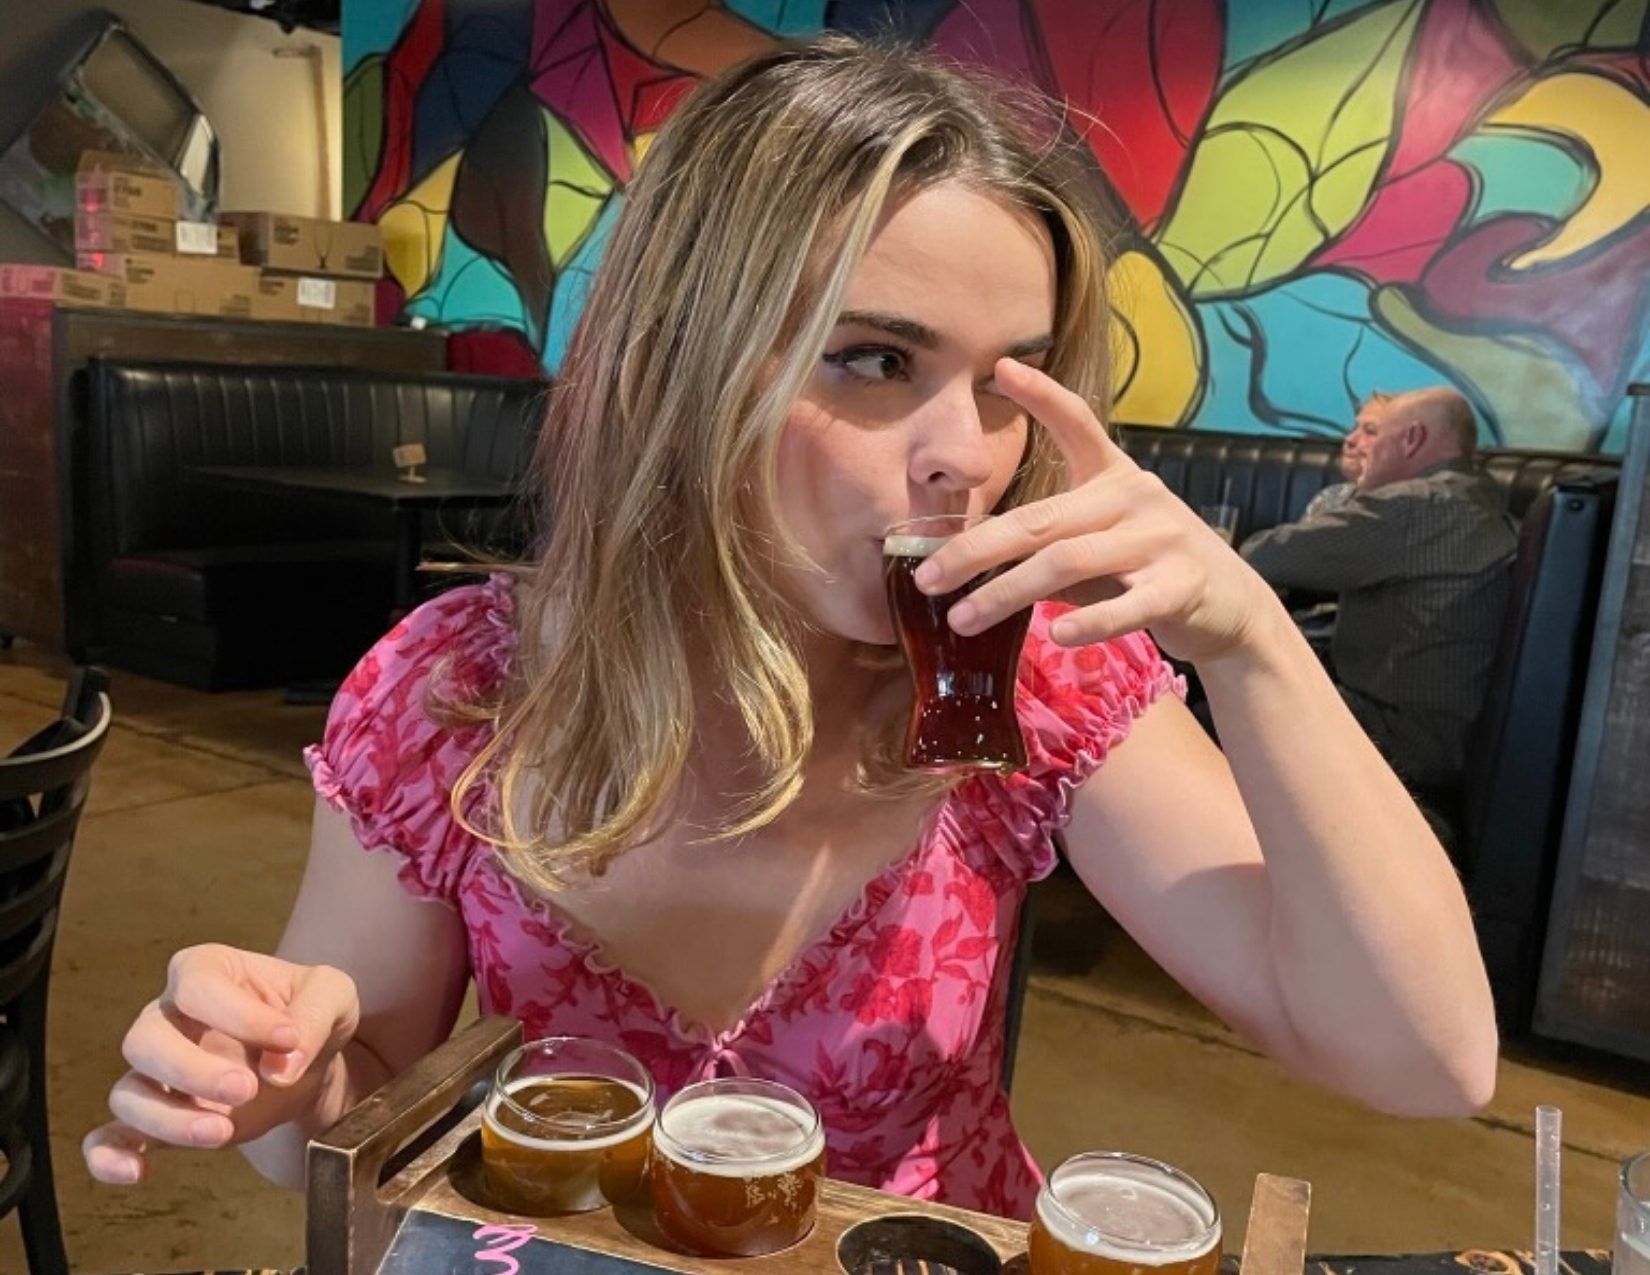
[305,577,1175,1217]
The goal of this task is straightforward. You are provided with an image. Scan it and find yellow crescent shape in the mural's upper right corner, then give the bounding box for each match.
[1483,73,1650,271]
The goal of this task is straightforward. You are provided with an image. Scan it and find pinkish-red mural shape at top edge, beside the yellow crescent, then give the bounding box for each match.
[1388,0,1525,180]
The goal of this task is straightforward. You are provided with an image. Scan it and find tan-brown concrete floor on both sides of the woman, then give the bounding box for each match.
[0,645,1650,1272]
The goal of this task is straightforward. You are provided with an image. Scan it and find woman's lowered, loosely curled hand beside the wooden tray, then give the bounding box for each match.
[83,943,361,1183]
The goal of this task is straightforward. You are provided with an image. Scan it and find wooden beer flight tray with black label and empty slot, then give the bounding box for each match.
[307,1018,1310,1275]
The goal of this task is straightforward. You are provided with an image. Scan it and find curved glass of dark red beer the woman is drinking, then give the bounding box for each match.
[883,515,1031,774]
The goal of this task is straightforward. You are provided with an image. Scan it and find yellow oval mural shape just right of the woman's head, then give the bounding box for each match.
[1107,251,1203,426]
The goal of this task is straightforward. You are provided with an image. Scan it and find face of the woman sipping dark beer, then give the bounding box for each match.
[777,185,1054,645]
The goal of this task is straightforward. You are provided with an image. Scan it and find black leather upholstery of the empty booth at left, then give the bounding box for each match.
[76,361,543,688]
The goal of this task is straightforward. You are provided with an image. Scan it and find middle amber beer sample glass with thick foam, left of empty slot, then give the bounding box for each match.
[648,1079,825,1257]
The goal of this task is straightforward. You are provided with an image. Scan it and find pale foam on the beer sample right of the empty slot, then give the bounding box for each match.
[1036,1156,1221,1267]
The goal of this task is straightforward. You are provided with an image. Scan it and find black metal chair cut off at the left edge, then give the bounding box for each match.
[0,668,111,1275]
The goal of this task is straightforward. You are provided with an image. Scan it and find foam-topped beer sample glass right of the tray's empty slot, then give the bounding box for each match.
[1030,1151,1221,1275]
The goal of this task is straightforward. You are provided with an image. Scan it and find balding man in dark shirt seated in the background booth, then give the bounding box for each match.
[1242,388,1518,790]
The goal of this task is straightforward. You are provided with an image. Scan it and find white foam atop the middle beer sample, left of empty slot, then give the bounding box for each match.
[657,1094,825,1178]
